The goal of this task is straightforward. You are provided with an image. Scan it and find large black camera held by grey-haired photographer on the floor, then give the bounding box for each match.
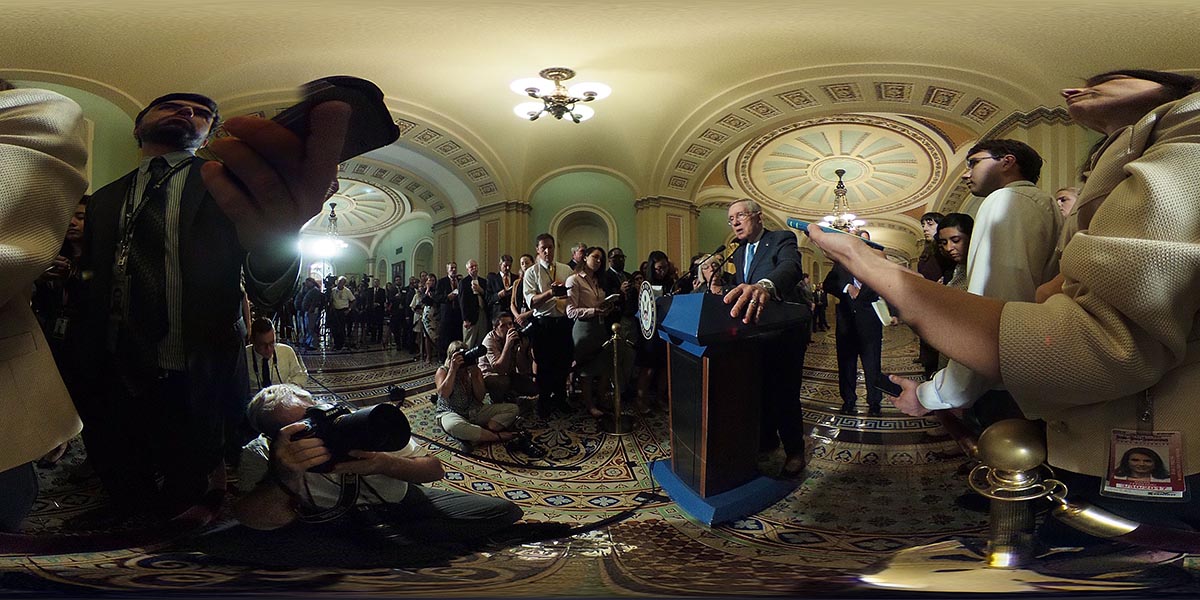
[292,403,413,473]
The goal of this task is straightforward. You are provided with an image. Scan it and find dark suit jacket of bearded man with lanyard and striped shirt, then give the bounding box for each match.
[83,158,297,475]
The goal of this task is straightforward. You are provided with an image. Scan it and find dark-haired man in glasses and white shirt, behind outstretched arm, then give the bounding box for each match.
[917,139,1062,427]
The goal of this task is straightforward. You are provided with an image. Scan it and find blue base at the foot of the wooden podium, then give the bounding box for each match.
[650,458,799,526]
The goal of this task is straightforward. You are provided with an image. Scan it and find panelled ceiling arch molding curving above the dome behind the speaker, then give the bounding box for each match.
[654,65,1038,198]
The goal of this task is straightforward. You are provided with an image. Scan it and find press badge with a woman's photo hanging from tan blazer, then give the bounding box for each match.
[1100,430,1189,502]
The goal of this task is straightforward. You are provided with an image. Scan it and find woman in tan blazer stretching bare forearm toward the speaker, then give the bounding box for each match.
[810,70,1200,542]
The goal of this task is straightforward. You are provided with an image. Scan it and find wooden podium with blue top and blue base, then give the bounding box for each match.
[652,294,805,524]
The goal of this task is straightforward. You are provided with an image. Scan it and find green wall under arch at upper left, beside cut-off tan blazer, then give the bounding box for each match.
[12,80,138,191]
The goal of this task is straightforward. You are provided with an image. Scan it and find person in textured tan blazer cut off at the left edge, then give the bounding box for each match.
[0,84,88,532]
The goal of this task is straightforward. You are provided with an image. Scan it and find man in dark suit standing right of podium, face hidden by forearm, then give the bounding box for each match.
[824,232,883,416]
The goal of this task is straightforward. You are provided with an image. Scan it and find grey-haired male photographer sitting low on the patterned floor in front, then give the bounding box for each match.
[233,384,522,542]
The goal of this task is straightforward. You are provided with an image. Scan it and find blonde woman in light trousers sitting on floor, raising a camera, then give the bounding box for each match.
[433,341,517,443]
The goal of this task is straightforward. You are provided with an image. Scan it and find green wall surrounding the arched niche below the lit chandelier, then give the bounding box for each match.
[528,172,642,258]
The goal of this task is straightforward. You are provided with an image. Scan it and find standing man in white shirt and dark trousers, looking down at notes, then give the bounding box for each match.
[521,233,575,416]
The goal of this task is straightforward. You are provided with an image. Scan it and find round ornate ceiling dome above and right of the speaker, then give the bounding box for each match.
[734,114,949,218]
